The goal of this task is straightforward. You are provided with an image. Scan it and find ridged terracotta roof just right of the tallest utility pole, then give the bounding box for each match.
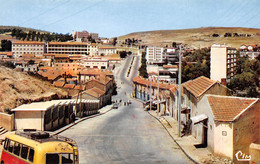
[182,76,217,97]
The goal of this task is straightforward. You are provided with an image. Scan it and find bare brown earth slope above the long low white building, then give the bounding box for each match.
[0,66,67,112]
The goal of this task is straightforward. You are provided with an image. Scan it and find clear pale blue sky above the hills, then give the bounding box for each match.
[0,0,260,38]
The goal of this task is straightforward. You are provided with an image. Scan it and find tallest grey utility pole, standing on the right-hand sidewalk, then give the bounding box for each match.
[178,45,181,137]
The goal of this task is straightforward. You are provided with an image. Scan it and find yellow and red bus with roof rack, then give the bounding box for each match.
[0,129,79,164]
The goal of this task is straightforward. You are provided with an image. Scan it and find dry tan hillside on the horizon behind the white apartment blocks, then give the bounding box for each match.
[118,27,260,48]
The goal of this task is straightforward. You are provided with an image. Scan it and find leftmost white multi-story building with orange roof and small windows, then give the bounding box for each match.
[12,41,45,58]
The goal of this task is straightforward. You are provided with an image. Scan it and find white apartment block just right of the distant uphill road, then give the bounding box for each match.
[146,47,163,64]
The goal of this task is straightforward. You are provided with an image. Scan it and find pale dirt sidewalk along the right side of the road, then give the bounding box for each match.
[148,111,232,164]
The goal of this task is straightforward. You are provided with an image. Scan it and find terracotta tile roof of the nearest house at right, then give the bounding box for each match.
[207,95,259,122]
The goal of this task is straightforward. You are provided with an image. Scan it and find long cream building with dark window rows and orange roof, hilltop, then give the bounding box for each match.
[46,42,90,55]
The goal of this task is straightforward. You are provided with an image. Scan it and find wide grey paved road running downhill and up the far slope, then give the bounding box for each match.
[61,56,191,164]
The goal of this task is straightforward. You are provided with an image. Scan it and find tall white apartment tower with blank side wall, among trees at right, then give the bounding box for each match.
[210,44,237,84]
